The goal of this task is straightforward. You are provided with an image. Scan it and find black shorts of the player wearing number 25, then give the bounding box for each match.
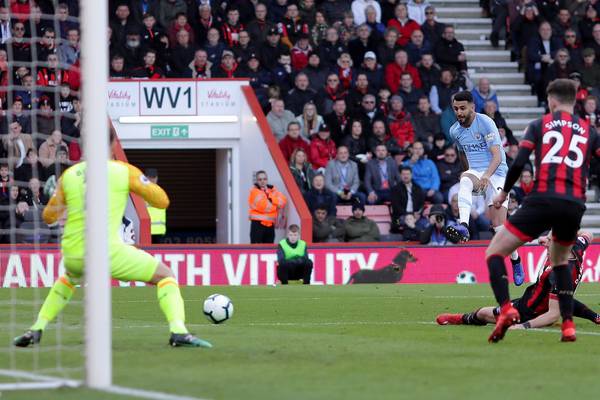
[504,196,585,246]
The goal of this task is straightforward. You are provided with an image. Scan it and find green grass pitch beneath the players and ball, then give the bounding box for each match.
[0,284,600,400]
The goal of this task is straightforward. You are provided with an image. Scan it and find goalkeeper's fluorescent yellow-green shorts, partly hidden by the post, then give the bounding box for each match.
[63,243,159,282]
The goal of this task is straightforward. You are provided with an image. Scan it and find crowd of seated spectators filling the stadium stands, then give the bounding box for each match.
[0,0,600,244]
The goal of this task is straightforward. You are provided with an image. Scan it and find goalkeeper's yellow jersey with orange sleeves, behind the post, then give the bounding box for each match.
[43,161,169,256]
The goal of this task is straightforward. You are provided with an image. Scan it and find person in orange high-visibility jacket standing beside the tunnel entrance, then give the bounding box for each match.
[248,171,287,243]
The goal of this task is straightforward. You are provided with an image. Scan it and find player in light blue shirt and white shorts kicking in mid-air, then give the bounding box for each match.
[446,91,525,286]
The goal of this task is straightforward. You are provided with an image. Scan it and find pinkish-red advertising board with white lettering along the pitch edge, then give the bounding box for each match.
[0,244,600,287]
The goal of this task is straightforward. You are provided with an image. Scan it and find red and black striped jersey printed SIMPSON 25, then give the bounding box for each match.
[520,112,600,203]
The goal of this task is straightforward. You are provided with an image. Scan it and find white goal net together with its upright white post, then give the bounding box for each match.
[0,0,111,393]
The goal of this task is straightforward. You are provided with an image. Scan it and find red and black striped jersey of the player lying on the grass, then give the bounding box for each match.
[522,236,590,316]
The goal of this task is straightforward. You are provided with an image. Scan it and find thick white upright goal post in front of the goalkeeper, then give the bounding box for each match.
[81,0,112,389]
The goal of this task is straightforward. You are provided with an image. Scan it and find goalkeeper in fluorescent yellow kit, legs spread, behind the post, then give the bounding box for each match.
[14,129,212,347]
